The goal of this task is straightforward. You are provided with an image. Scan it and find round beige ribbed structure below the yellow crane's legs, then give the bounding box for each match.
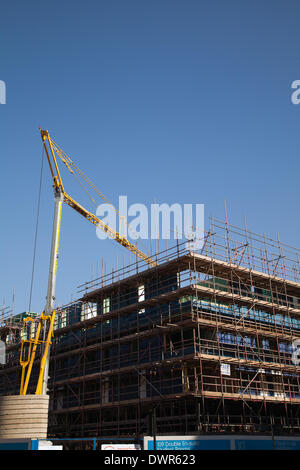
[0,395,49,439]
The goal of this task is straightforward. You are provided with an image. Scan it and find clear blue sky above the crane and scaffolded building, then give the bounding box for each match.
[0,0,300,312]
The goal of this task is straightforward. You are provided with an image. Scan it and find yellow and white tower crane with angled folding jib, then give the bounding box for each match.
[20,129,156,395]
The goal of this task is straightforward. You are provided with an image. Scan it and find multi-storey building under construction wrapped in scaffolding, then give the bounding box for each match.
[0,219,300,438]
